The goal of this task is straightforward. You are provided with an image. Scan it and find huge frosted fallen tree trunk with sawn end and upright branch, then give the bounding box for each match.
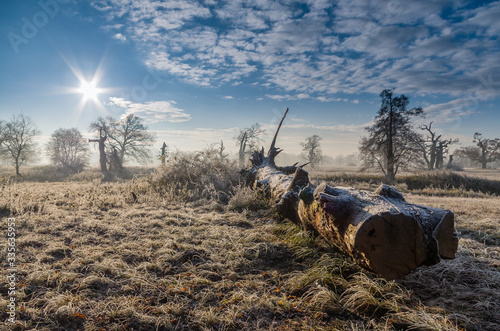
[247,109,458,279]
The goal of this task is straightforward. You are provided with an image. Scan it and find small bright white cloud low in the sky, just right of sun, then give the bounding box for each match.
[108,97,191,123]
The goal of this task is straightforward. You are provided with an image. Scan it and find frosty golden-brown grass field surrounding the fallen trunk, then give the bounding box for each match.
[0,165,500,330]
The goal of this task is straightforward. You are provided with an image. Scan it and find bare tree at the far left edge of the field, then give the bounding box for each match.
[0,114,40,176]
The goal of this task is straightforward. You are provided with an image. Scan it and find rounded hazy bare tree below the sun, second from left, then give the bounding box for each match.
[45,128,89,173]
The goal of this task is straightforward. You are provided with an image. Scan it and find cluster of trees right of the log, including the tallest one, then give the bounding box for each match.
[359,89,500,183]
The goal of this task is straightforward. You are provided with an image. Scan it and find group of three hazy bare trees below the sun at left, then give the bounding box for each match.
[0,114,156,176]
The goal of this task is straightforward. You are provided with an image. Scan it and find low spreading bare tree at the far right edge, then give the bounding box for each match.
[457,132,500,169]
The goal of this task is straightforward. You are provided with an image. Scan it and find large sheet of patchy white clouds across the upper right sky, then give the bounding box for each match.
[92,0,500,102]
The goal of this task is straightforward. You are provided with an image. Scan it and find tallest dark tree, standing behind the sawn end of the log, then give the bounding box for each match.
[359,89,423,183]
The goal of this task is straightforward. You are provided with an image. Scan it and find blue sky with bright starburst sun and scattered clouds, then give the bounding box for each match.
[0,0,500,165]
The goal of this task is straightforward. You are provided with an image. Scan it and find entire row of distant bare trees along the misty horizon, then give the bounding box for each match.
[0,97,500,179]
